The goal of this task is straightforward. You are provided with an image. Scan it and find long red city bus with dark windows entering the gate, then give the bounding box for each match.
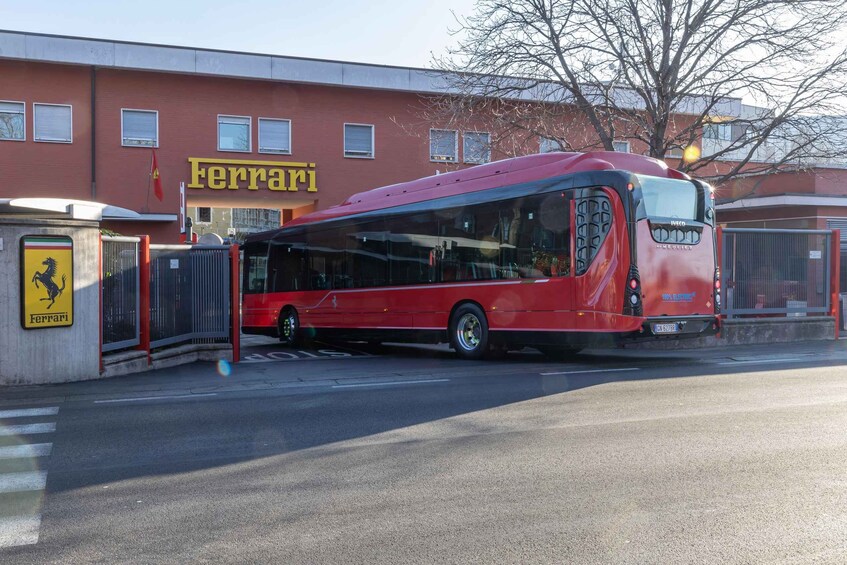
[242,152,720,359]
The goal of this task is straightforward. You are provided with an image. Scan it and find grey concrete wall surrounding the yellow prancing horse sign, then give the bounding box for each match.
[0,217,100,385]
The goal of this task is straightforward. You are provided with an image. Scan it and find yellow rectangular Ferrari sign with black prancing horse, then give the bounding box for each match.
[21,235,74,329]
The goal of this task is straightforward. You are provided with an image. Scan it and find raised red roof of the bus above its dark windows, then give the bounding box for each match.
[255,151,689,235]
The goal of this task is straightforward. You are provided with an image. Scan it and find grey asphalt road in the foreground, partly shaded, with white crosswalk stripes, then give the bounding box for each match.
[0,342,847,564]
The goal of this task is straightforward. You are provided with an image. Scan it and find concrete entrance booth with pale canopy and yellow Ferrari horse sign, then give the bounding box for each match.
[0,198,112,385]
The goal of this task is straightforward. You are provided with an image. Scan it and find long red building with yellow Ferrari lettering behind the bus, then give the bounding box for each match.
[0,31,847,243]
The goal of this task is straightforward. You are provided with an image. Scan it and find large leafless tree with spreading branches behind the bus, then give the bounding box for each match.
[434,0,847,183]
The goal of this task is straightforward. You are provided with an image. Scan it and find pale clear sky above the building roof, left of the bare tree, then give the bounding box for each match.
[0,0,474,68]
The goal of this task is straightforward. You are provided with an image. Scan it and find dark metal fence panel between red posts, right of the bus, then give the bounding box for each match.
[721,228,833,318]
